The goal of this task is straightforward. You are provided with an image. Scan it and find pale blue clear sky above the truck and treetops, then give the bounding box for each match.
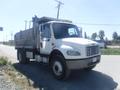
[0,0,120,41]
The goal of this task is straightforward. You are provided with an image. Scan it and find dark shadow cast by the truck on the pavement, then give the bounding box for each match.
[14,62,117,90]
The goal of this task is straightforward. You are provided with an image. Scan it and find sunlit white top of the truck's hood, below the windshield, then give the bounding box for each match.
[56,38,97,46]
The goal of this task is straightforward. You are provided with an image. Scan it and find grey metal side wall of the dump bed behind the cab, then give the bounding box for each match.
[15,28,38,49]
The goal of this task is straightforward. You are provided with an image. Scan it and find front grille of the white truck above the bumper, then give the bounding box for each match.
[86,46,99,56]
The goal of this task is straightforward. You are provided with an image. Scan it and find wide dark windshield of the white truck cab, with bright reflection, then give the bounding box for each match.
[53,23,80,39]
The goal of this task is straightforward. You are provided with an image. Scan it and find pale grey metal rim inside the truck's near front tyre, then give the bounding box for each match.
[53,61,63,76]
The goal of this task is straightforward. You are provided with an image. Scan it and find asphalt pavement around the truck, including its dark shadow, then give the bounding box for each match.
[0,45,120,90]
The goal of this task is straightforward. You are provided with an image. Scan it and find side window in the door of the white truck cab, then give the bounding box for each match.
[41,24,51,38]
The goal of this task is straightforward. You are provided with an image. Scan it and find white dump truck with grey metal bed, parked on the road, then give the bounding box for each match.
[14,16,101,80]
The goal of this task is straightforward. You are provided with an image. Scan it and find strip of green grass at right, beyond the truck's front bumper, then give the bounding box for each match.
[101,48,120,55]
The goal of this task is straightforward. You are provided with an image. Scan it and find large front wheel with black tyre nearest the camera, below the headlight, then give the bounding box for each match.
[50,55,70,80]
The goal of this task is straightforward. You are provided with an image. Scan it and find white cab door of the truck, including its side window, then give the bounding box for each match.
[40,24,52,55]
